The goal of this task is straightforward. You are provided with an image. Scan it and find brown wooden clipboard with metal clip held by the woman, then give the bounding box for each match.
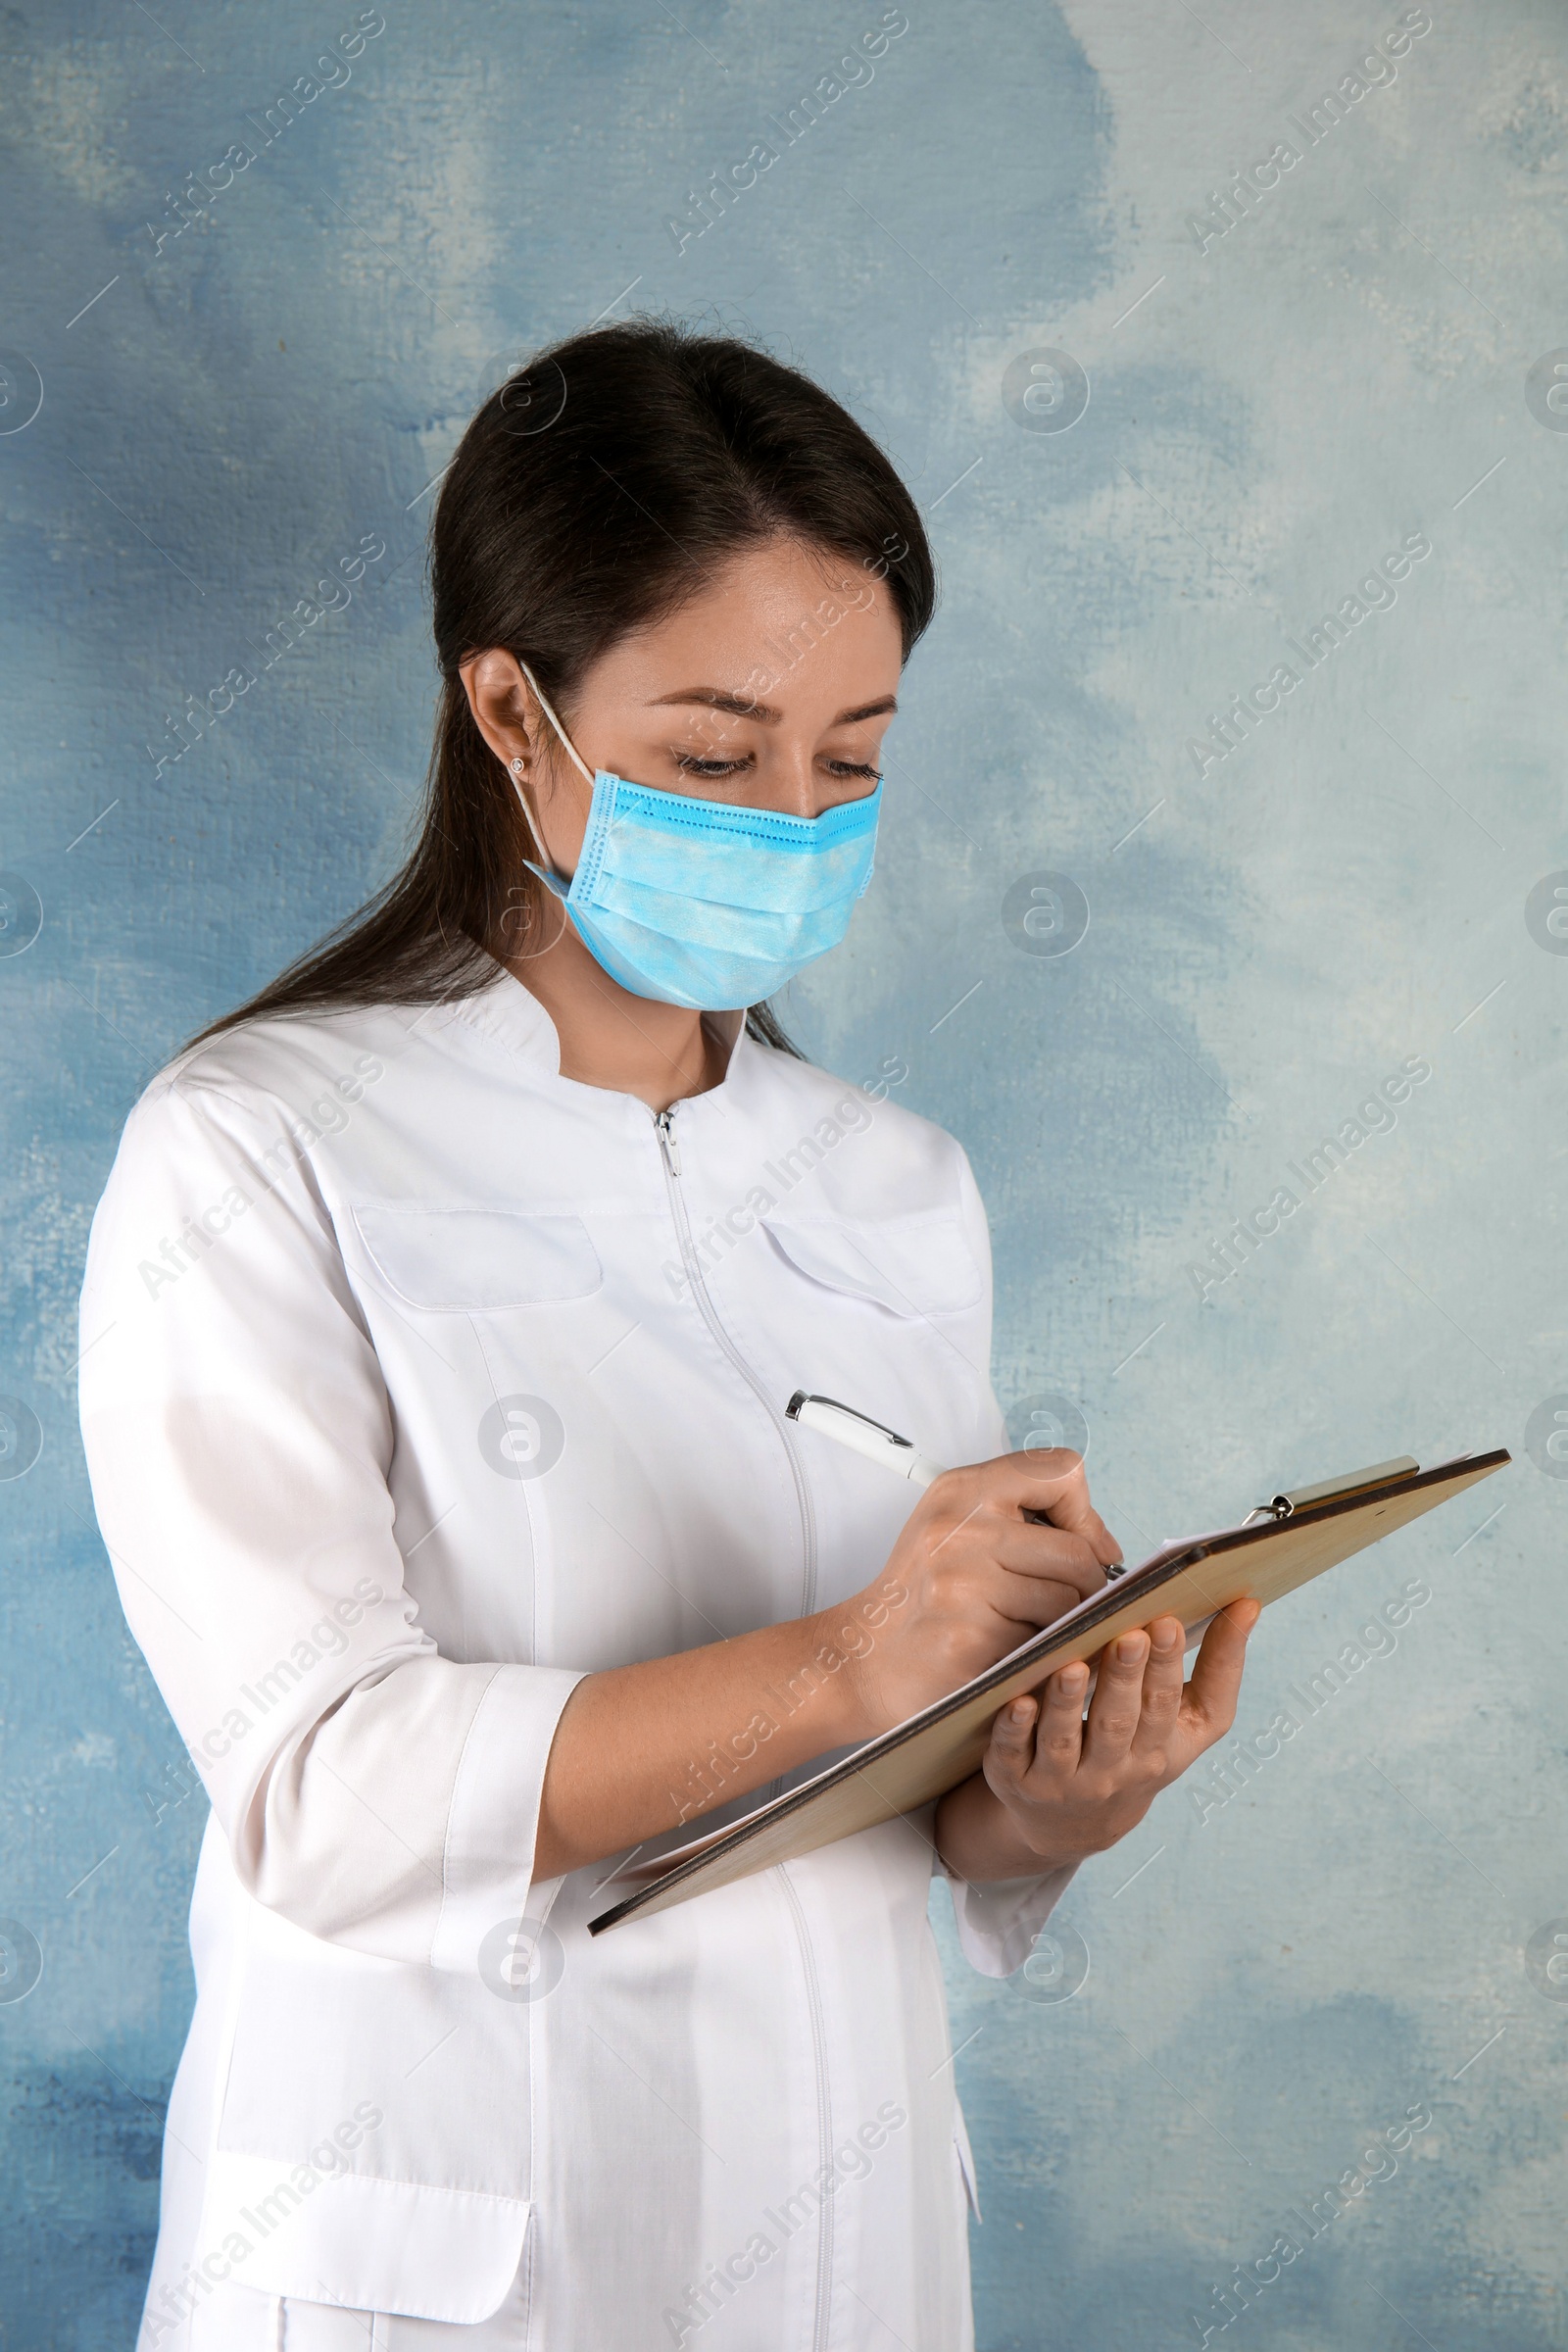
[588,1446,1511,1936]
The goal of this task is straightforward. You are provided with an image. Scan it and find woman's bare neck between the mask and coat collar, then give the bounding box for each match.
[508,901,738,1110]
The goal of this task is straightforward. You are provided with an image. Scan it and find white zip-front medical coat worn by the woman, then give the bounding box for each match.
[80,971,1067,2352]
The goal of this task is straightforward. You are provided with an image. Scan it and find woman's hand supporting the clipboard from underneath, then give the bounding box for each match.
[936,1601,1260,1880]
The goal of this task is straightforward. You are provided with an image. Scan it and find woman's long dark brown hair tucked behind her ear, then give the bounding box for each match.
[205,319,936,1052]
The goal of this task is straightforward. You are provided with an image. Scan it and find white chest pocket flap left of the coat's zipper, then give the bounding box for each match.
[353,1204,604,1315]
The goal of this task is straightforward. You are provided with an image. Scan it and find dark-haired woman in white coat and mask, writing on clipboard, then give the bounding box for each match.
[82,324,1250,2352]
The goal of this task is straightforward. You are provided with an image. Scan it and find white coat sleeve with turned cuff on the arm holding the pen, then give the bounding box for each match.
[80,1077,581,1971]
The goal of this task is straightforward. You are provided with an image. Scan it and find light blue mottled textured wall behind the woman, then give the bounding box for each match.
[0,0,1568,2352]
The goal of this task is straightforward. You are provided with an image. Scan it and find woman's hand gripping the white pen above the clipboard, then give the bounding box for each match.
[820,1446,1121,1739]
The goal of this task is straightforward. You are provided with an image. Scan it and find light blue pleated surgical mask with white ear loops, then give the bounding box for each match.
[513,665,882,1013]
